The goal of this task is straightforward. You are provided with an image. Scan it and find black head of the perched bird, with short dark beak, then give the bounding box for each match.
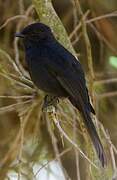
[15,23,53,42]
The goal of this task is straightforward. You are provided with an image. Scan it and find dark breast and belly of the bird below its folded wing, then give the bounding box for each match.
[27,54,67,97]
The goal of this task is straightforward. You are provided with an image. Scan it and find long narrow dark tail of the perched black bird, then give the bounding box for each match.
[70,99,106,167]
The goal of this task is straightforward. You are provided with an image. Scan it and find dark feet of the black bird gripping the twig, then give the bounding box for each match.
[42,95,59,111]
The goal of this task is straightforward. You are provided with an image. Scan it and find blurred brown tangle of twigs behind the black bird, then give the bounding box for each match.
[0,0,117,180]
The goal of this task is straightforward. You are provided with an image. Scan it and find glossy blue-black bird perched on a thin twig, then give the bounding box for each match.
[16,23,106,166]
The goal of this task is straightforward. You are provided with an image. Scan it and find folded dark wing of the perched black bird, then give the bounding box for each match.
[47,43,90,111]
